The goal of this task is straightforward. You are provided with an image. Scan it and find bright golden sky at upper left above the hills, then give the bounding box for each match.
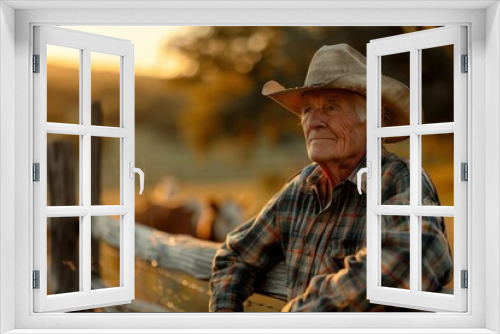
[47,26,189,78]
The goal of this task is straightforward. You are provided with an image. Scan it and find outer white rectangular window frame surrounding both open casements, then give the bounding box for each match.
[0,1,500,333]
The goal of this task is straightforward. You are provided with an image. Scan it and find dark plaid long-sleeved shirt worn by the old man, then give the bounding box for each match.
[209,149,452,312]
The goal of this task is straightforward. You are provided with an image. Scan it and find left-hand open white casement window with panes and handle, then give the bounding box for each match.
[33,26,143,312]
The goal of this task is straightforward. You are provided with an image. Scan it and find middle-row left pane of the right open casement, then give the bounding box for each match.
[380,138,410,205]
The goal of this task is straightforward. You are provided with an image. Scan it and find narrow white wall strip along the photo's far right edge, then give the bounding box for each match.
[485,3,500,333]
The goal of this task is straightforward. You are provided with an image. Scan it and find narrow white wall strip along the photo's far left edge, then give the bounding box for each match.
[0,2,15,333]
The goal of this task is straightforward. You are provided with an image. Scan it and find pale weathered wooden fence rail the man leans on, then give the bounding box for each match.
[92,217,286,299]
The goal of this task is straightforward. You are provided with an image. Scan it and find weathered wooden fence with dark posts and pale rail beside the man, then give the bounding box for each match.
[47,102,286,312]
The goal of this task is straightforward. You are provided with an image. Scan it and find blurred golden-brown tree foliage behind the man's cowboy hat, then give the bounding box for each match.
[167,27,446,152]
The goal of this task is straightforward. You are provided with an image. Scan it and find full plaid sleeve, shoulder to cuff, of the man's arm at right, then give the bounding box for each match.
[282,166,452,312]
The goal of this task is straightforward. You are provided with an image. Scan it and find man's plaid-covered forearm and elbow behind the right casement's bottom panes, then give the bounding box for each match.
[283,219,452,312]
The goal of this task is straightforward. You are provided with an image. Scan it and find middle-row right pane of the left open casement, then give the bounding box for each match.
[91,137,121,205]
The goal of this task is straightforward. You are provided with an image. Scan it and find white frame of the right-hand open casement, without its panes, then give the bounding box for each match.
[366,25,468,312]
